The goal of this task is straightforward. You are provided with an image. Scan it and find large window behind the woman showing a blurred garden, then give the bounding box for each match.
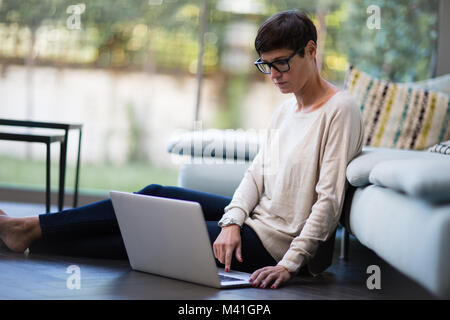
[0,0,439,196]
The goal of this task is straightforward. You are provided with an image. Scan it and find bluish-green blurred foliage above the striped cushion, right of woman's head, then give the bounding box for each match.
[336,0,439,82]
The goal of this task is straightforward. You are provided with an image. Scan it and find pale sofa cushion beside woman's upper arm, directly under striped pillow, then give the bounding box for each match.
[346,146,448,187]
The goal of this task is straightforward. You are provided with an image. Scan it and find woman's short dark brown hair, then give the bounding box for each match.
[255,10,317,57]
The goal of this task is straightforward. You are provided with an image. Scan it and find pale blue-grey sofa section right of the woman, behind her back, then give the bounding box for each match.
[340,146,450,299]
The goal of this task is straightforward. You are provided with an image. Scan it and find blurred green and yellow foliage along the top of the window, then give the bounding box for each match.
[0,0,439,82]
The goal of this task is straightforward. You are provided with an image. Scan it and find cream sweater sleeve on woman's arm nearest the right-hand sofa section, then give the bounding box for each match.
[278,103,364,273]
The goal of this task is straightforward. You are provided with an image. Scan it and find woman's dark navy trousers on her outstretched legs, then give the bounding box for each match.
[30,184,276,272]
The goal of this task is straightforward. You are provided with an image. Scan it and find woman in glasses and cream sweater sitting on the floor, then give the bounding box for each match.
[0,11,363,288]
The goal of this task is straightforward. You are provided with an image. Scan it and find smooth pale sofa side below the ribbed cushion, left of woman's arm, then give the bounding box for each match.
[178,162,251,198]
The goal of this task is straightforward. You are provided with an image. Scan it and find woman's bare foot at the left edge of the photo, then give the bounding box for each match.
[0,210,41,252]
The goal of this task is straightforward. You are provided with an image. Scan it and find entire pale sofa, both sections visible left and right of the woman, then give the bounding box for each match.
[167,130,450,298]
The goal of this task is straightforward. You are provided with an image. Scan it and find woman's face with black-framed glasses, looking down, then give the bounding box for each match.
[261,47,315,93]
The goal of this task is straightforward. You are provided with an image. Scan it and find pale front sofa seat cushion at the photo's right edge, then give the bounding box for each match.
[369,157,450,202]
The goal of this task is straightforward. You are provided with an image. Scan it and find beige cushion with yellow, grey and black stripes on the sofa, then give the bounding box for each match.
[345,66,450,150]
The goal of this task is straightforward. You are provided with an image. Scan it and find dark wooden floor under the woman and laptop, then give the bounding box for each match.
[0,202,433,300]
